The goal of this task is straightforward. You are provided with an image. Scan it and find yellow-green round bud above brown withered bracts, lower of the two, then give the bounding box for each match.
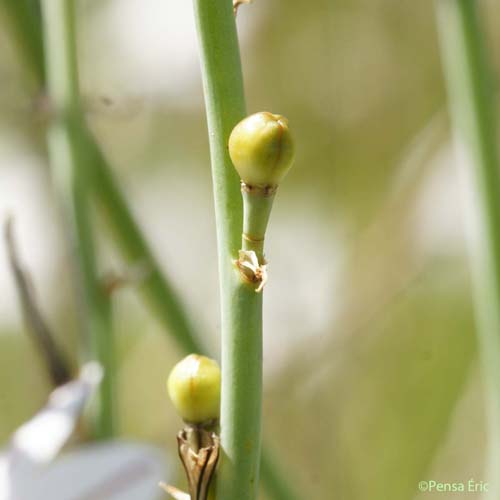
[167,354,221,424]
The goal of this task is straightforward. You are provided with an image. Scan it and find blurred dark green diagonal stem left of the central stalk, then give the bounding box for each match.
[0,0,205,354]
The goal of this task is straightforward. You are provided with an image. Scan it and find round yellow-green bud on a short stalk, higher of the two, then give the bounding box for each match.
[229,112,295,187]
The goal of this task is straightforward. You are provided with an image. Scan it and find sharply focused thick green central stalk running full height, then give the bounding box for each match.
[189,0,262,500]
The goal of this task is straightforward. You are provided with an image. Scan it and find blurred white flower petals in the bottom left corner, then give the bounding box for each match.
[0,363,166,500]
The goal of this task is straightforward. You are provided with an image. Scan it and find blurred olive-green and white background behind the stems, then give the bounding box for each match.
[0,0,500,500]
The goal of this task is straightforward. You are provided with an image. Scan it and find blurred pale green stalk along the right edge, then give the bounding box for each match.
[437,0,500,499]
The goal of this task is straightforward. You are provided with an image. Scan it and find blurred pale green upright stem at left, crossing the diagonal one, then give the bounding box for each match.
[41,0,115,438]
